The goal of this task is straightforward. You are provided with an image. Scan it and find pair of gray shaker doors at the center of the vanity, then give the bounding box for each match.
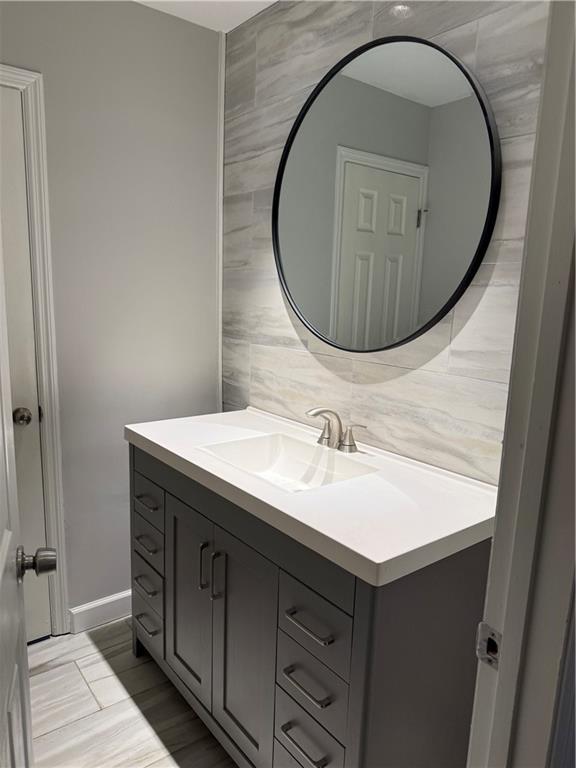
[164,493,278,768]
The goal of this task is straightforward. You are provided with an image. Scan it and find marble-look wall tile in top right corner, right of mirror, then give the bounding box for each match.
[476,2,549,138]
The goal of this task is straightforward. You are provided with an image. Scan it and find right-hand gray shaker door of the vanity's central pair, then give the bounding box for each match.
[212,526,278,768]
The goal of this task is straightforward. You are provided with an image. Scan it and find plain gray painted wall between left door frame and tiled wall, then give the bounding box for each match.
[0,2,218,606]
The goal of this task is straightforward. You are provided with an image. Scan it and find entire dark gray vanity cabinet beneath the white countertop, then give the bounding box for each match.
[130,447,490,768]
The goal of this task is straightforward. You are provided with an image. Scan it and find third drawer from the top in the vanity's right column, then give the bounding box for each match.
[274,686,344,768]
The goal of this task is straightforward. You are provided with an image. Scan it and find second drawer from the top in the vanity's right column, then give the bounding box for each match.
[276,630,348,743]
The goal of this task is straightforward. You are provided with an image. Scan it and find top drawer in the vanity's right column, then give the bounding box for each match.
[278,572,352,681]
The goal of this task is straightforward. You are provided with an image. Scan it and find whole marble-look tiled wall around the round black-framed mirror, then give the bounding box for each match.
[223,0,548,483]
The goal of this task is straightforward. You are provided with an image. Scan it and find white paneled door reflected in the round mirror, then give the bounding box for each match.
[336,162,421,349]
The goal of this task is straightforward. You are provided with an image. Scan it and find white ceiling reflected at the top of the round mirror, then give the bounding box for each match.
[341,42,472,107]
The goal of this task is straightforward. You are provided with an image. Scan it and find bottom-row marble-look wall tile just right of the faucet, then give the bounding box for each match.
[351,361,507,483]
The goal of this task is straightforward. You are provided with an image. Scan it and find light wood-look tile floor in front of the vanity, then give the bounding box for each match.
[28,619,235,768]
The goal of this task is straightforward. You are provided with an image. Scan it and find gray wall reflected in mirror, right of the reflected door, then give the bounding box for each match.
[420,96,490,322]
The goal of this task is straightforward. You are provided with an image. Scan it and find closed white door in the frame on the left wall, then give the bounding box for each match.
[0,87,51,641]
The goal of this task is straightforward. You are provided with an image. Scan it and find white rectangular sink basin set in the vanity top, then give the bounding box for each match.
[202,434,378,491]
